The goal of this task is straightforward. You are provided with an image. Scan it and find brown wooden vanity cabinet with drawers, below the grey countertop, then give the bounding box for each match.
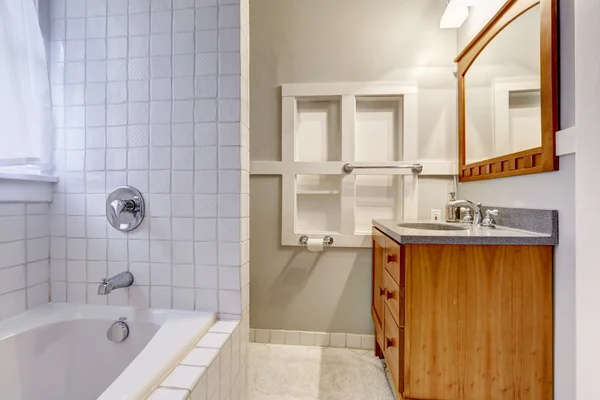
[371,229,553,400]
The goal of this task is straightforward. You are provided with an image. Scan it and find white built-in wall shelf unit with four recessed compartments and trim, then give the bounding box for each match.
[251,82,456,247]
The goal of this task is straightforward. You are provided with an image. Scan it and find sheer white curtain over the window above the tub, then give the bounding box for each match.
[0,0,52,171]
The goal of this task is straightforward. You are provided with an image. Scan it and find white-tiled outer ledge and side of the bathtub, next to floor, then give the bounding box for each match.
[149,321,248,400]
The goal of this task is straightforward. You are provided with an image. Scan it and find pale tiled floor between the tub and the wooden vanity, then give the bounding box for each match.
[248,343,394,400]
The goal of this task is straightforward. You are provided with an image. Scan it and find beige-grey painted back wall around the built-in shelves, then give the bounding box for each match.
[250,0,457,333]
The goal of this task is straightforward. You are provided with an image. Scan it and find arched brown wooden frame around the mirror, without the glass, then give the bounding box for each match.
[454,0,558,182]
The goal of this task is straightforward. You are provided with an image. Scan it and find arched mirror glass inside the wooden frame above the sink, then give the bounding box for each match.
[464,5,542,164]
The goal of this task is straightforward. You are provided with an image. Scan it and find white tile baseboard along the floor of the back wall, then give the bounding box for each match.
[250,328,375,350]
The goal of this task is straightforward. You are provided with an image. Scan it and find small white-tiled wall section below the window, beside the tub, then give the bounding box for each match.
[0,203,50,321]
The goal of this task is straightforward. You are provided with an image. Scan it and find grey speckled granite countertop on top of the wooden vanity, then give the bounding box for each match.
[373,219,558,245]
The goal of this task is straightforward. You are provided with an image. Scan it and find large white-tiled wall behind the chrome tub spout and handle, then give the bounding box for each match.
[51,0,249,319]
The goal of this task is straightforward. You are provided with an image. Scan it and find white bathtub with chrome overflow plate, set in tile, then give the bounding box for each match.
[0,304,215,400]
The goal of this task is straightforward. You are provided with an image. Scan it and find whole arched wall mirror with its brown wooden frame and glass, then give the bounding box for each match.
[455,0,558,182]
